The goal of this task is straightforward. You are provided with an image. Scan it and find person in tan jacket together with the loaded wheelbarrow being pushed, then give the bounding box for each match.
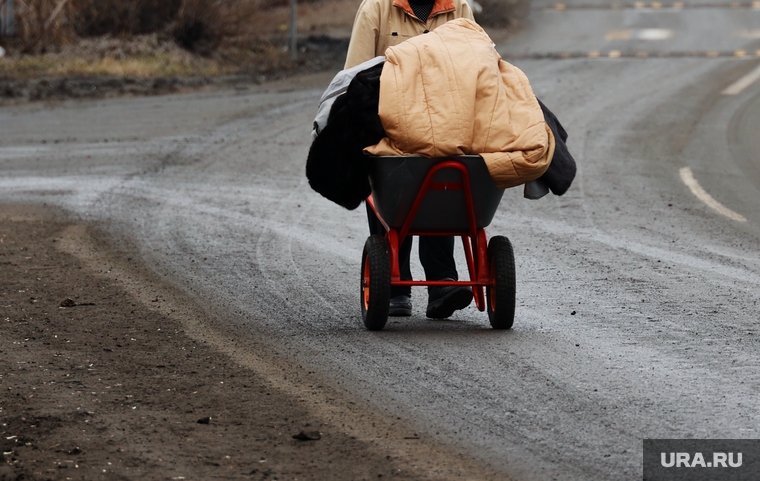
[306,0,575,330]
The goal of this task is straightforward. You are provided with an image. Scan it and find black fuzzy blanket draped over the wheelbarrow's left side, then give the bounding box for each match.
[306,63,385,210]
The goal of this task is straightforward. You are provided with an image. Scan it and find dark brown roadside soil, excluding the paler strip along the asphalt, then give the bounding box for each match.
[0,208,470,480]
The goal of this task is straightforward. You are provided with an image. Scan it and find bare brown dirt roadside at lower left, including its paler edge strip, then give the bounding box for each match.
[0,206,504,480]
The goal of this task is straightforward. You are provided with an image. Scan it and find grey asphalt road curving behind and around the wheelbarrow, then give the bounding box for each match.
[0,2,760,480]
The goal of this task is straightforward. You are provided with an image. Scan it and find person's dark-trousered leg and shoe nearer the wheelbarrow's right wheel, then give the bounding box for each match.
[420,236,472,319]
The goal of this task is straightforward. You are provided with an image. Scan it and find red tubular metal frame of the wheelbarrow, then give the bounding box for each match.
[367,160,495,311]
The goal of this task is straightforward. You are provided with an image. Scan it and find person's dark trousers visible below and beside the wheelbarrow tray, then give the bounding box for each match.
[367,204,459,297]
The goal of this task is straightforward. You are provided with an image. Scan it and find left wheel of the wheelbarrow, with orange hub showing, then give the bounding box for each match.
[361,235,391,331]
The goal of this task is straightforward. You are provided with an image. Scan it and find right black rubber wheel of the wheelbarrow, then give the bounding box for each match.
[486,236,515,329]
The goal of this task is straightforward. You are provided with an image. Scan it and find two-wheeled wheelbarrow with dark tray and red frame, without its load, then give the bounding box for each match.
[361,155,515,331]
